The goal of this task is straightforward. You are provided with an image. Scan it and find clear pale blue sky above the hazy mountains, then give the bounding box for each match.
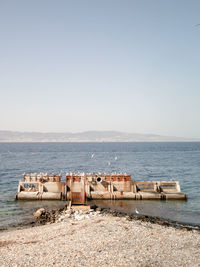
[0,0,200,138]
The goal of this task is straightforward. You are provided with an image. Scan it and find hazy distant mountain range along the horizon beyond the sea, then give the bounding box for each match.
[0,131,200,142]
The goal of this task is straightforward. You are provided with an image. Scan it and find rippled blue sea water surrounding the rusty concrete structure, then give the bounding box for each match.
[0,142,200,228]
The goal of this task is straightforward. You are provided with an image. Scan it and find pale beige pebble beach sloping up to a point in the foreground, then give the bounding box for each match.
[0,210,200,267]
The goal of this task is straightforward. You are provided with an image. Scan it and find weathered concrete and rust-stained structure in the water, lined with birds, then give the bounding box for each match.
[15,173,187,204]
